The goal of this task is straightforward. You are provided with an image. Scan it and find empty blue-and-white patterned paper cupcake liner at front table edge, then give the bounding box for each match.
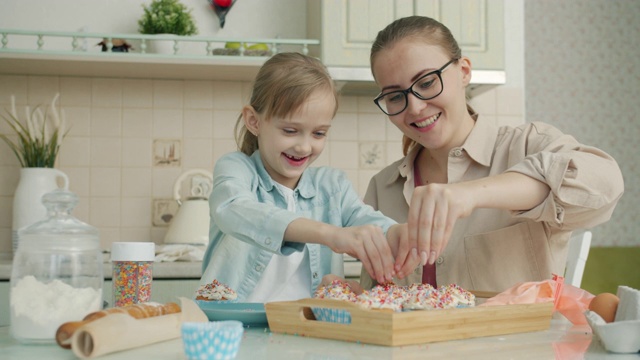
[182,320,244,360]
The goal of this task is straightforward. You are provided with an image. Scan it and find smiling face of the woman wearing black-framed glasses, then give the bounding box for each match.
[373,37,472,151]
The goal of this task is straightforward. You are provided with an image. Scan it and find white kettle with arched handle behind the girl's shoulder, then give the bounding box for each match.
[164,169,213,245]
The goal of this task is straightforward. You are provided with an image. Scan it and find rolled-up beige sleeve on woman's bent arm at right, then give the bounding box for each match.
[507,123,624,229]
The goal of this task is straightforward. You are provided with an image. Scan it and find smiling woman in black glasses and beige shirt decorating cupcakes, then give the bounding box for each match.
[362,16,623,291]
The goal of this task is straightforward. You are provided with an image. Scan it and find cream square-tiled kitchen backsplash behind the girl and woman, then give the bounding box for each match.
[0,75,524,253]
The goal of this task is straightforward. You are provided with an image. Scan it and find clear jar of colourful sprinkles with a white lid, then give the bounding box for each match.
[111,242,155,307]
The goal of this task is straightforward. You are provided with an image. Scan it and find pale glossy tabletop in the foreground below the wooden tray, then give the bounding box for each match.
[0,319,640,360]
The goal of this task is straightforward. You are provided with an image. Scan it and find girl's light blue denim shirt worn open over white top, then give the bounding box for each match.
[200,151,396,301]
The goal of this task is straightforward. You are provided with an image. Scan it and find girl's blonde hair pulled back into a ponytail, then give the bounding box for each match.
[235,52,338,155]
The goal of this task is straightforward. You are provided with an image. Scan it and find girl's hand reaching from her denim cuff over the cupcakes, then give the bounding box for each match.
[327,225,395,284]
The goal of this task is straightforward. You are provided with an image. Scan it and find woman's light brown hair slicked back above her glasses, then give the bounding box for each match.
[369,16,475,155]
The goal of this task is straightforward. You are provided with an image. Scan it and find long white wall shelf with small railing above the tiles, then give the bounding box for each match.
[0,29,320,81]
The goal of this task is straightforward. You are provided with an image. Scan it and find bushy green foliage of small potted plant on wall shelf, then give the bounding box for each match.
[138,0,198,36]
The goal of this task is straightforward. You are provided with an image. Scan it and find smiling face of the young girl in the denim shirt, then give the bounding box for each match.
[245,89,336,189]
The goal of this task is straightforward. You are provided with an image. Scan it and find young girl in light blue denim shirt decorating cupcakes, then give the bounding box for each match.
[201,53,419,302]
